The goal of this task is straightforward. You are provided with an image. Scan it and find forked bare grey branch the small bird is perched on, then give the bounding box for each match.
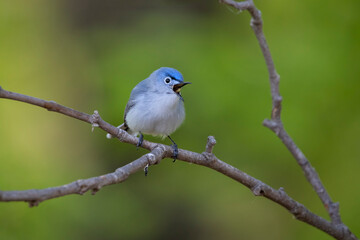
[0,87,356,239]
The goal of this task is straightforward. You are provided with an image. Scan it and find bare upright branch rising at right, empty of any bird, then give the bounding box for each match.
[221,0,342,227]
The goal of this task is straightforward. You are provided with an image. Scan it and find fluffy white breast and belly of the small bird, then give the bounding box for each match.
[126,92,185,137]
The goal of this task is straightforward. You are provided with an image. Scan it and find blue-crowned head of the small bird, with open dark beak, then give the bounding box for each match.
[151,67,191,99]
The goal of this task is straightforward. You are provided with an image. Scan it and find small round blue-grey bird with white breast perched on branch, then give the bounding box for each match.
[106,67,190,162]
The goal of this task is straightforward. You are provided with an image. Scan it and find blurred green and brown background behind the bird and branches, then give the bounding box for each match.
[0,0,360,240]
